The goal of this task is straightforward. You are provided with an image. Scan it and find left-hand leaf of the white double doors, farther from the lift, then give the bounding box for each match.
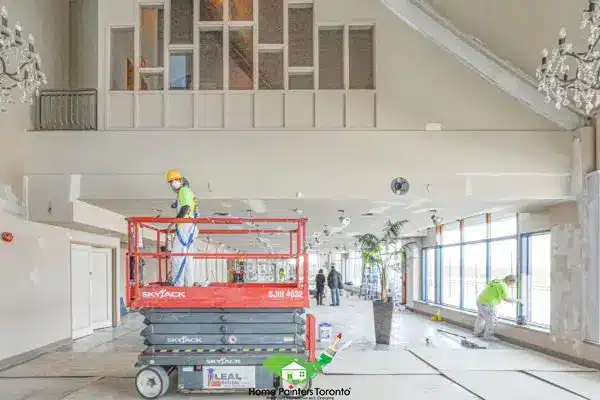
[71,244,93,339]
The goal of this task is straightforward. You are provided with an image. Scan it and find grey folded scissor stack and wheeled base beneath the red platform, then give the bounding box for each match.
[136,308,310,399]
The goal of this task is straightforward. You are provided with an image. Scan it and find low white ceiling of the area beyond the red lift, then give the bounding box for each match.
[89,198,550,252]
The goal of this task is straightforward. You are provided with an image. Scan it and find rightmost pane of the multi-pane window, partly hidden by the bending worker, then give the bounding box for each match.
[490,238,517,319]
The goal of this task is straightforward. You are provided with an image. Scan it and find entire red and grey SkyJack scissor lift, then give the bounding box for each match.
[126,217,316,399]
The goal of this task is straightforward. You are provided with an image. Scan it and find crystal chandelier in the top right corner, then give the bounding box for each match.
[536,0,600,116]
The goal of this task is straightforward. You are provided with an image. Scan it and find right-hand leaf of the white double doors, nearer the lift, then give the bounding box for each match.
[92,248,113,329]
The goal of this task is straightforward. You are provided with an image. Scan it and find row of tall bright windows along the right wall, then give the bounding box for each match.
[422,214,551,327]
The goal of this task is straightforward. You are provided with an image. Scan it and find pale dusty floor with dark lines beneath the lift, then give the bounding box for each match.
[0,297,600,400]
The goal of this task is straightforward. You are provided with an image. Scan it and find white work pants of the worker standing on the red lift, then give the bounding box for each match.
[171,224,196,286]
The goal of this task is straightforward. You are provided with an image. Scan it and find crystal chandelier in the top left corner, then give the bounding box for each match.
[0,6,47,112]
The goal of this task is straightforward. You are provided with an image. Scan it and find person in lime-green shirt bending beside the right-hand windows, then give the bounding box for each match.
[474,275,521,340]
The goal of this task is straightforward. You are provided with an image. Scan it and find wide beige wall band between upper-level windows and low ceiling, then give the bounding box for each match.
[27,131,572,202]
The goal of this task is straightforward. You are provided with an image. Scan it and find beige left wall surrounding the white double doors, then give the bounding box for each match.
[0,211,120,360]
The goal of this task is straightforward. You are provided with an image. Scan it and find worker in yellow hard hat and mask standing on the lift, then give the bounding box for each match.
[167,170,198,286]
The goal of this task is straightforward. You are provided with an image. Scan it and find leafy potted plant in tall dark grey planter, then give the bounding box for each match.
[357,220,412,344]
